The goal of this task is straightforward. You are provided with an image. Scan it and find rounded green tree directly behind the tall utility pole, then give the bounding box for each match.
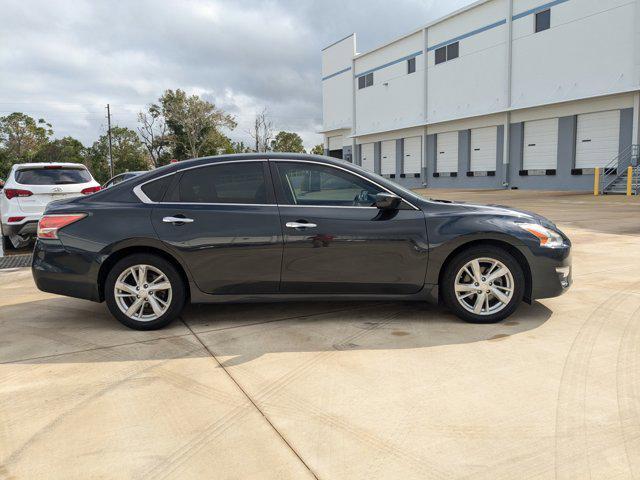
[86,126,151,183]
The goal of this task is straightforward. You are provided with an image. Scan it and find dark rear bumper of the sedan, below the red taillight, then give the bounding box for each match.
[31,240,101,302]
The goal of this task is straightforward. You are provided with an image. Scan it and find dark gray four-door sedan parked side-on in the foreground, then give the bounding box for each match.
[32,153,571,330]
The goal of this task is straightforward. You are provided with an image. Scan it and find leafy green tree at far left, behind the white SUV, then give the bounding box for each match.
[0,112,53,164]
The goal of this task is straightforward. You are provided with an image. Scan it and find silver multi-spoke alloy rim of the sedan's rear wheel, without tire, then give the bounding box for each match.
[113,265,173,322]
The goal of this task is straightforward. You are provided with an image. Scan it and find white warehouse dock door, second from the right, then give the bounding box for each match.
[522,118,558,170]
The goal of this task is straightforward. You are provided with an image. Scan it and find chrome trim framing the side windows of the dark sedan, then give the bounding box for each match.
[133,158,420,210]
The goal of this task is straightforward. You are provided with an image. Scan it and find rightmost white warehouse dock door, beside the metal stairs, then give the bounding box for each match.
[576,110,620,168]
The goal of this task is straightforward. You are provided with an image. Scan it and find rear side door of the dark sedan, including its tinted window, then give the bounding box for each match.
[152,162,282,294]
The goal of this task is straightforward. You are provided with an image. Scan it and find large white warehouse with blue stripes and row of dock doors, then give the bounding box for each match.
[322,0,640,190]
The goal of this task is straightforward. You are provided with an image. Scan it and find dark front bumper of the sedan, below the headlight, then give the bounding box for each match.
[521,245,573,301]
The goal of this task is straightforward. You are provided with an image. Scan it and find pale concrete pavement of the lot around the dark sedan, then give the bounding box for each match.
[0,191,640,479]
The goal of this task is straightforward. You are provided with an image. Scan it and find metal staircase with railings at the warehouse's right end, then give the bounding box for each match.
[599,145,640,195]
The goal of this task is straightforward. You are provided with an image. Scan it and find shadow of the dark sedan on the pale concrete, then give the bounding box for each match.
[0,297,552,367]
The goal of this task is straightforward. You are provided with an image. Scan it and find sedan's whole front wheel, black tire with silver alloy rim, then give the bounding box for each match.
[440,245,525,323]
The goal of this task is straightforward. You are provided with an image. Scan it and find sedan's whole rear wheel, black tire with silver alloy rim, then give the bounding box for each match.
[104,253,186,330]
